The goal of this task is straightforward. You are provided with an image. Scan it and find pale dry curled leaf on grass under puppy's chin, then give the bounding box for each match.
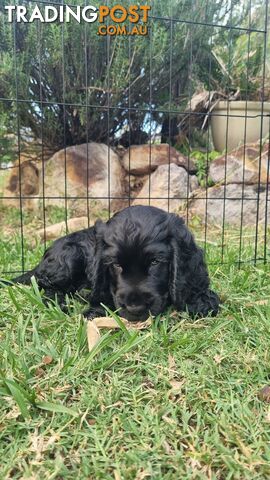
[87,317,151,352]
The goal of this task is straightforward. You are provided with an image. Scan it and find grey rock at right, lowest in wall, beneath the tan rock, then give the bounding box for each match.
[188,183,270,226]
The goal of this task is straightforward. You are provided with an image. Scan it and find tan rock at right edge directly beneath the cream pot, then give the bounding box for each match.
[209,144,270,184]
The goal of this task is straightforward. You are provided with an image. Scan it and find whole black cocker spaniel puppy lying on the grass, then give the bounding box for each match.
[13,206,219,321]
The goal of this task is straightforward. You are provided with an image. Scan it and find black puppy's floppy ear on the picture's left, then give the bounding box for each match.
[86,220,110,305]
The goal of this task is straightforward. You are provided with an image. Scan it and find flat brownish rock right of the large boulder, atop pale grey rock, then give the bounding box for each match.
[122,143,196,175]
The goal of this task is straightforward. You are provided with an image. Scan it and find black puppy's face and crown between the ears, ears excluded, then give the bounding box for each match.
[96,206,171,321]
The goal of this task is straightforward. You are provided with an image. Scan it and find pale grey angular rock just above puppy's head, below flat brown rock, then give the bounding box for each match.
[133,163,198,211]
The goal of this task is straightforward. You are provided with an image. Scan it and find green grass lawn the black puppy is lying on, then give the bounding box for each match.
[0,231,270,480]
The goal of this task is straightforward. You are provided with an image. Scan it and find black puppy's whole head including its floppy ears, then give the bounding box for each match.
[95,206,219,320]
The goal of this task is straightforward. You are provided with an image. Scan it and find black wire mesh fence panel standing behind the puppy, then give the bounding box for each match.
[0,0,270,275]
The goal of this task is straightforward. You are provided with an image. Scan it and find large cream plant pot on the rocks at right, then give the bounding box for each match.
[211,101,270,152]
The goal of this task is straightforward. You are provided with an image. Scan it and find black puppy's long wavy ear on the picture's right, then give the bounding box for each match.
[169,214,219,316]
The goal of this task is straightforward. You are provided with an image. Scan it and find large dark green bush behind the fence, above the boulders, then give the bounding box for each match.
[0,0,251,148]
